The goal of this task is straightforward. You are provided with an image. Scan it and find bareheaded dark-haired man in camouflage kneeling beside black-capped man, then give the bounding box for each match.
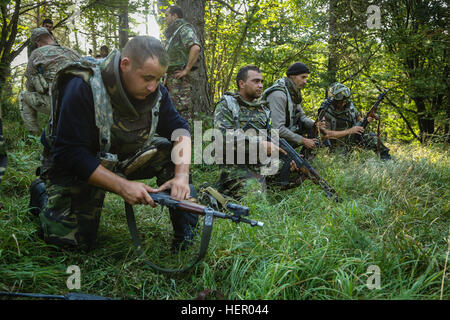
[214,65,300,199]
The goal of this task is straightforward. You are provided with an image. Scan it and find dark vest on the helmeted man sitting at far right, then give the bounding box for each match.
[319,98,358,131]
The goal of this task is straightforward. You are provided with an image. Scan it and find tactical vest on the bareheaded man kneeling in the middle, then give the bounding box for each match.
[219,92,272,130]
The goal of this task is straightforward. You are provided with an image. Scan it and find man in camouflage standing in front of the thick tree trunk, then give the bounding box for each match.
[164,6,201,125]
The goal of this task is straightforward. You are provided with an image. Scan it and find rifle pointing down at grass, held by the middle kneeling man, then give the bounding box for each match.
[243,122,339,201]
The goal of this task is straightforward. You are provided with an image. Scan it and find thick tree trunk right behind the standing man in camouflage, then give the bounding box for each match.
[178,0,212,114]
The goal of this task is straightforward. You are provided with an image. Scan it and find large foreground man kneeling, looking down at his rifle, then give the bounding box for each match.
[31,36,197,250]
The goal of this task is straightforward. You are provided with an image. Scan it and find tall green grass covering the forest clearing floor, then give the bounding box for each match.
[0,115,450,300]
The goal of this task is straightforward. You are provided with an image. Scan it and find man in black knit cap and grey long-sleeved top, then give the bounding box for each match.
[262,62,316,149]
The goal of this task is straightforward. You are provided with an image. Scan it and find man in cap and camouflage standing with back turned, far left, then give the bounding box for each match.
[19,28,81,135]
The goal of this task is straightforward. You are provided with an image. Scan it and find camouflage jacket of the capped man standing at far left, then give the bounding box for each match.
[25,44,81,93]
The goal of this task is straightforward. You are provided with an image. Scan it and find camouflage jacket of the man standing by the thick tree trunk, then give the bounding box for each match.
[165,19,201,72]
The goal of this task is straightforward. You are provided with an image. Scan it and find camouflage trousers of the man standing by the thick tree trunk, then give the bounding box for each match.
[166,72,194,127]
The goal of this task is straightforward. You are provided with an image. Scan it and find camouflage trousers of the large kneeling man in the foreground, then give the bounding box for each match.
[39,141,198,250]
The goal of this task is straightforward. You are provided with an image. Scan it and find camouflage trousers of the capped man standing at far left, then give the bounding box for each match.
[19,91,50,135]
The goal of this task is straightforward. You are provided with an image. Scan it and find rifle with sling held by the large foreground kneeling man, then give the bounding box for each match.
[125,192,264,273]
